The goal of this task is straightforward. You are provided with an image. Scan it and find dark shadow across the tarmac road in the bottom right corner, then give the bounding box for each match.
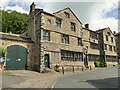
[86,77,120,90]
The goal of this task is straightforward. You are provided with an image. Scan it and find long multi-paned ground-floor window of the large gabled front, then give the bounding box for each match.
[61,50,83,61]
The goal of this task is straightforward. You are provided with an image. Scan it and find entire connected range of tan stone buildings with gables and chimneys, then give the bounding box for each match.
[2,3,117,72]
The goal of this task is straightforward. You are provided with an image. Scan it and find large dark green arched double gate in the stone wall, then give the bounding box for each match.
[6,45,27,70]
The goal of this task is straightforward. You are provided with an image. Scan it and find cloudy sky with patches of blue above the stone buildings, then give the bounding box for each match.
[0,0,118,32]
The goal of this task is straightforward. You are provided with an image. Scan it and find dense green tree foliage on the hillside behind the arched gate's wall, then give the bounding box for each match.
[2,10,29,34]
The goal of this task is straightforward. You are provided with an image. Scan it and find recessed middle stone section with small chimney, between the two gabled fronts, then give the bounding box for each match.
[82,24,100,62]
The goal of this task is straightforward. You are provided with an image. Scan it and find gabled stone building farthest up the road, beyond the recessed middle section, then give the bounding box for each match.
[96,27,117,62]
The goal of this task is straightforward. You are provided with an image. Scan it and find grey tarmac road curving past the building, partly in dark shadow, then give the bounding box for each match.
[49,66,120,89]
